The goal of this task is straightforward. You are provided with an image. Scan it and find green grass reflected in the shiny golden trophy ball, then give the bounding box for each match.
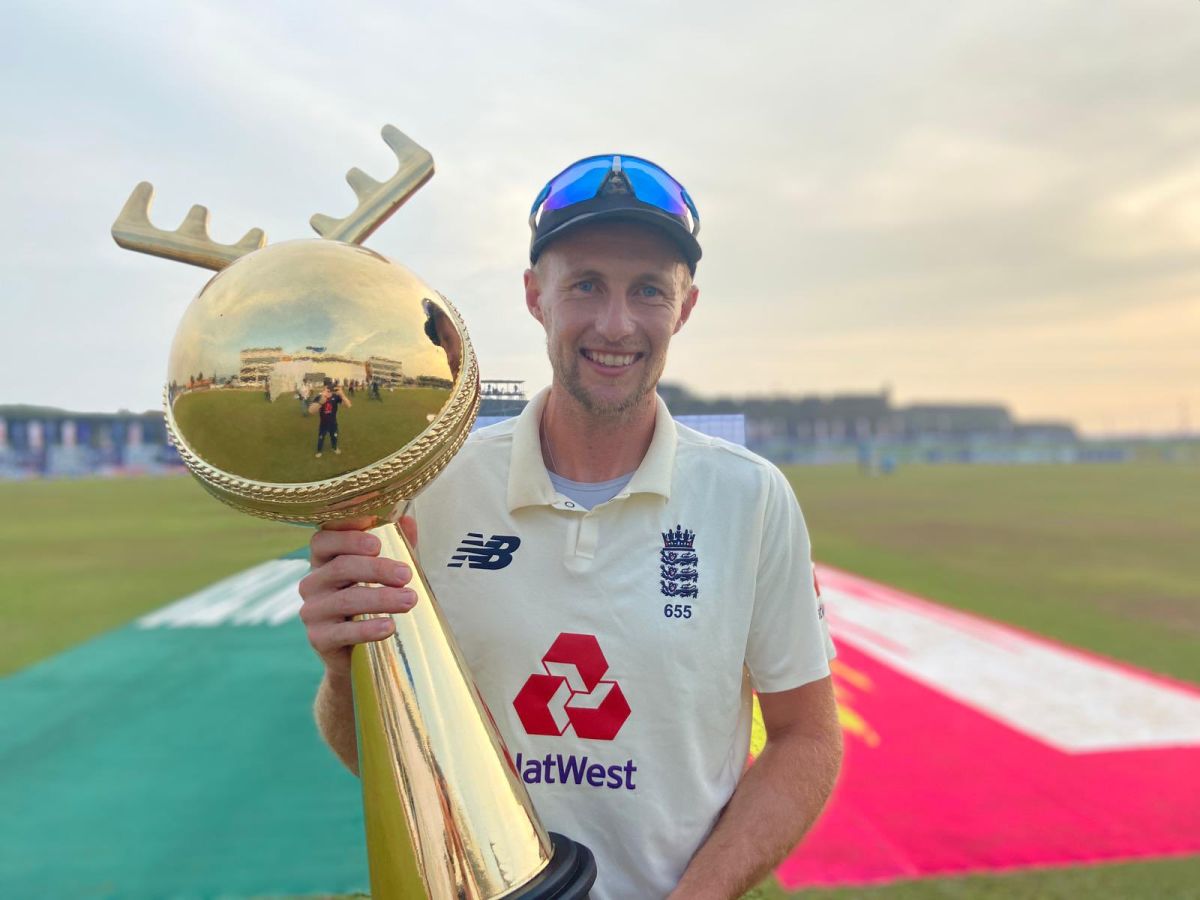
[174,388,450,484]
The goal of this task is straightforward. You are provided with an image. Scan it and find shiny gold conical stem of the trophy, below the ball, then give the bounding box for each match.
[352,524,556,900]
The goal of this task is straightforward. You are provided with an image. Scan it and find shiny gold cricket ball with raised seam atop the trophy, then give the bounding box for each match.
[166,240,478,523]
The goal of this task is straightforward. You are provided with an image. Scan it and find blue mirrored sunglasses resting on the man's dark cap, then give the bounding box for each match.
[529,154,700,235]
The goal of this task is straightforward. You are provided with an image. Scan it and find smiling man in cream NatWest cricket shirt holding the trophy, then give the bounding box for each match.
[301,156,841,900]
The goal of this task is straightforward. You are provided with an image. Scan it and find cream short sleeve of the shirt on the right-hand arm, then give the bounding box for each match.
[745,466,836,692]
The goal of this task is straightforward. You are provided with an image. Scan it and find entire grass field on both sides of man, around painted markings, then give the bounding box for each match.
[0,468,1200,900]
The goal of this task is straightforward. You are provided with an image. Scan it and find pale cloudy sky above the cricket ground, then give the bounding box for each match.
[0,0,1200,434]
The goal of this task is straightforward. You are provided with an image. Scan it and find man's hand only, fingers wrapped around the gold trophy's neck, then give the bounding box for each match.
[300,517,416,680]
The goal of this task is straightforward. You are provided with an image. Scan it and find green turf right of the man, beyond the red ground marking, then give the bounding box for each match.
[787,464,1200,683]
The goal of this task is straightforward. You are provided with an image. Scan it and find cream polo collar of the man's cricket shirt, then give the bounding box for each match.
[508,388,679,512]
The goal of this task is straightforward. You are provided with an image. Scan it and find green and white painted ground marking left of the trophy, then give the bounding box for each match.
[0,552,367,898]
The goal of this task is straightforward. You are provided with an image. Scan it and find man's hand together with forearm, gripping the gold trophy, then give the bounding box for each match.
[300,517,416,774]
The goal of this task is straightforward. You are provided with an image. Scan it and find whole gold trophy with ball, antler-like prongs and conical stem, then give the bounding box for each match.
[113,125,595,900]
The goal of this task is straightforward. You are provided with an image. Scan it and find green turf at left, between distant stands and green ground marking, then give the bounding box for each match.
[0,475,298,674]
